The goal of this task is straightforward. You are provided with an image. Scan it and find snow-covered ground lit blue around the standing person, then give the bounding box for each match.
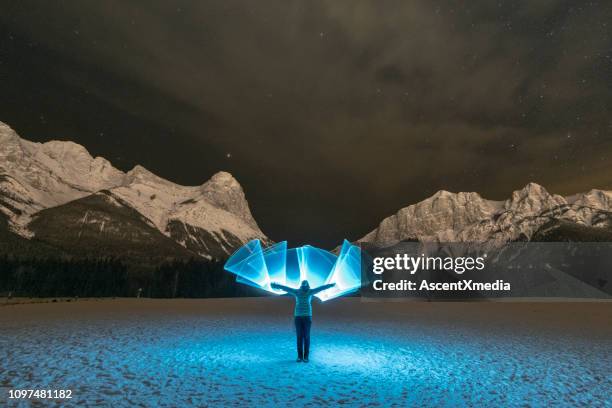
[0,297,612,407]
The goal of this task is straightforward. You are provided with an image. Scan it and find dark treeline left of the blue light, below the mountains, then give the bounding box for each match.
[0,255,260,298]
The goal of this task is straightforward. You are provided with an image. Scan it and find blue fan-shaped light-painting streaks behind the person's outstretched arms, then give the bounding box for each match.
[225,239,361,301]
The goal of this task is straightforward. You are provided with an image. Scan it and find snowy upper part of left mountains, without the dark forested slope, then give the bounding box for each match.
[0,122,267,258]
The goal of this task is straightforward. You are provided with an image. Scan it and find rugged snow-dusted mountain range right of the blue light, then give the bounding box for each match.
[359,183,612,247]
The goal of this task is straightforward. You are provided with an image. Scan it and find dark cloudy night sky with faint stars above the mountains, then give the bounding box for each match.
[0,0,612,247]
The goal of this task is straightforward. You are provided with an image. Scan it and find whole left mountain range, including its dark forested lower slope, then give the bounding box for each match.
[0,122,268,260]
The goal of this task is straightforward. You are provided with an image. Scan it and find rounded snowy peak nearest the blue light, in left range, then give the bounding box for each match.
[111,166,267,258]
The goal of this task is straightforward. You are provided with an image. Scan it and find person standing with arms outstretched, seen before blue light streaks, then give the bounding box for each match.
[270,280,336,363]
